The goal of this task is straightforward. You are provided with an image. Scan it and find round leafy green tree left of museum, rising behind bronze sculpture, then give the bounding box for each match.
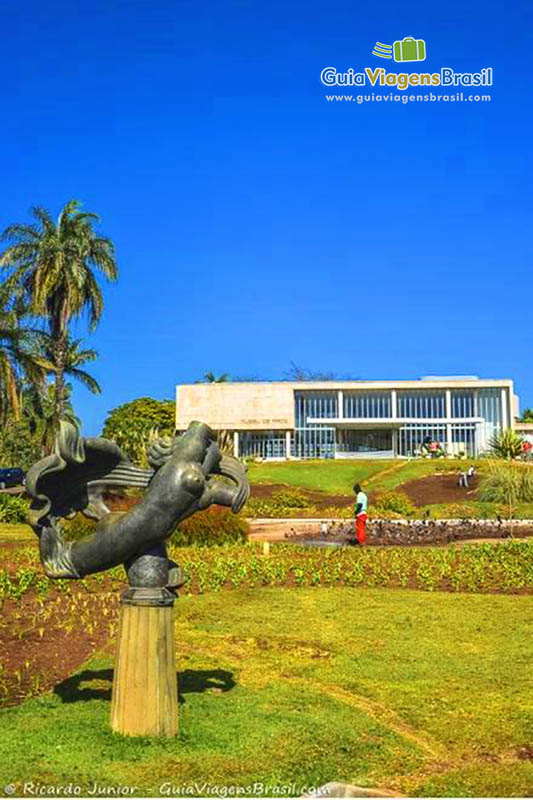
[102,397,176,466]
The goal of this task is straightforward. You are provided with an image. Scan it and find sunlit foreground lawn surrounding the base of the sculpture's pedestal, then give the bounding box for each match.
[0,588,533,796]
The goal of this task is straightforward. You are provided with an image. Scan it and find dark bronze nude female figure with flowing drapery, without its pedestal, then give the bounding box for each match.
[26,422,250,588]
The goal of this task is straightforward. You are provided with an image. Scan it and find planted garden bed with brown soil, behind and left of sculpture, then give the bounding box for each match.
[0,541,533,705]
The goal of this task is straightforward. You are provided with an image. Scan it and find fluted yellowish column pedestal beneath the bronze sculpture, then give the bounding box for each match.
[111,588,178,737]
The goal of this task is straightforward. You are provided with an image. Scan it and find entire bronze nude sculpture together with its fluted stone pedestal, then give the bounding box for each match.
[26,422,250,735]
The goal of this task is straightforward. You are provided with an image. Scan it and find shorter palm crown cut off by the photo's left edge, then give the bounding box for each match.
[0,284,51,424]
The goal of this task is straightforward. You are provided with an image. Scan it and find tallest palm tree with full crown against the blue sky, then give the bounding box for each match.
[0,200,118,420]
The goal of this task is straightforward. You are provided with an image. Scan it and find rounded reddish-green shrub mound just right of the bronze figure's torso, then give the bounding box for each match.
[170,506,248,547]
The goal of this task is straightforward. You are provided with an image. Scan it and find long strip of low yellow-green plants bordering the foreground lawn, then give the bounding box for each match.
[0,540,533,596]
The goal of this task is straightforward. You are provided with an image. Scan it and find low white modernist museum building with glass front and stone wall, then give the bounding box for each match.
[176,376,518,459]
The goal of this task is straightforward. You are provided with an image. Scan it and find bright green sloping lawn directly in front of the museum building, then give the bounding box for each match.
[248,459,482,495]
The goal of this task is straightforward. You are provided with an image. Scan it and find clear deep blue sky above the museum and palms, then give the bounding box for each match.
[0,0,533,433]
